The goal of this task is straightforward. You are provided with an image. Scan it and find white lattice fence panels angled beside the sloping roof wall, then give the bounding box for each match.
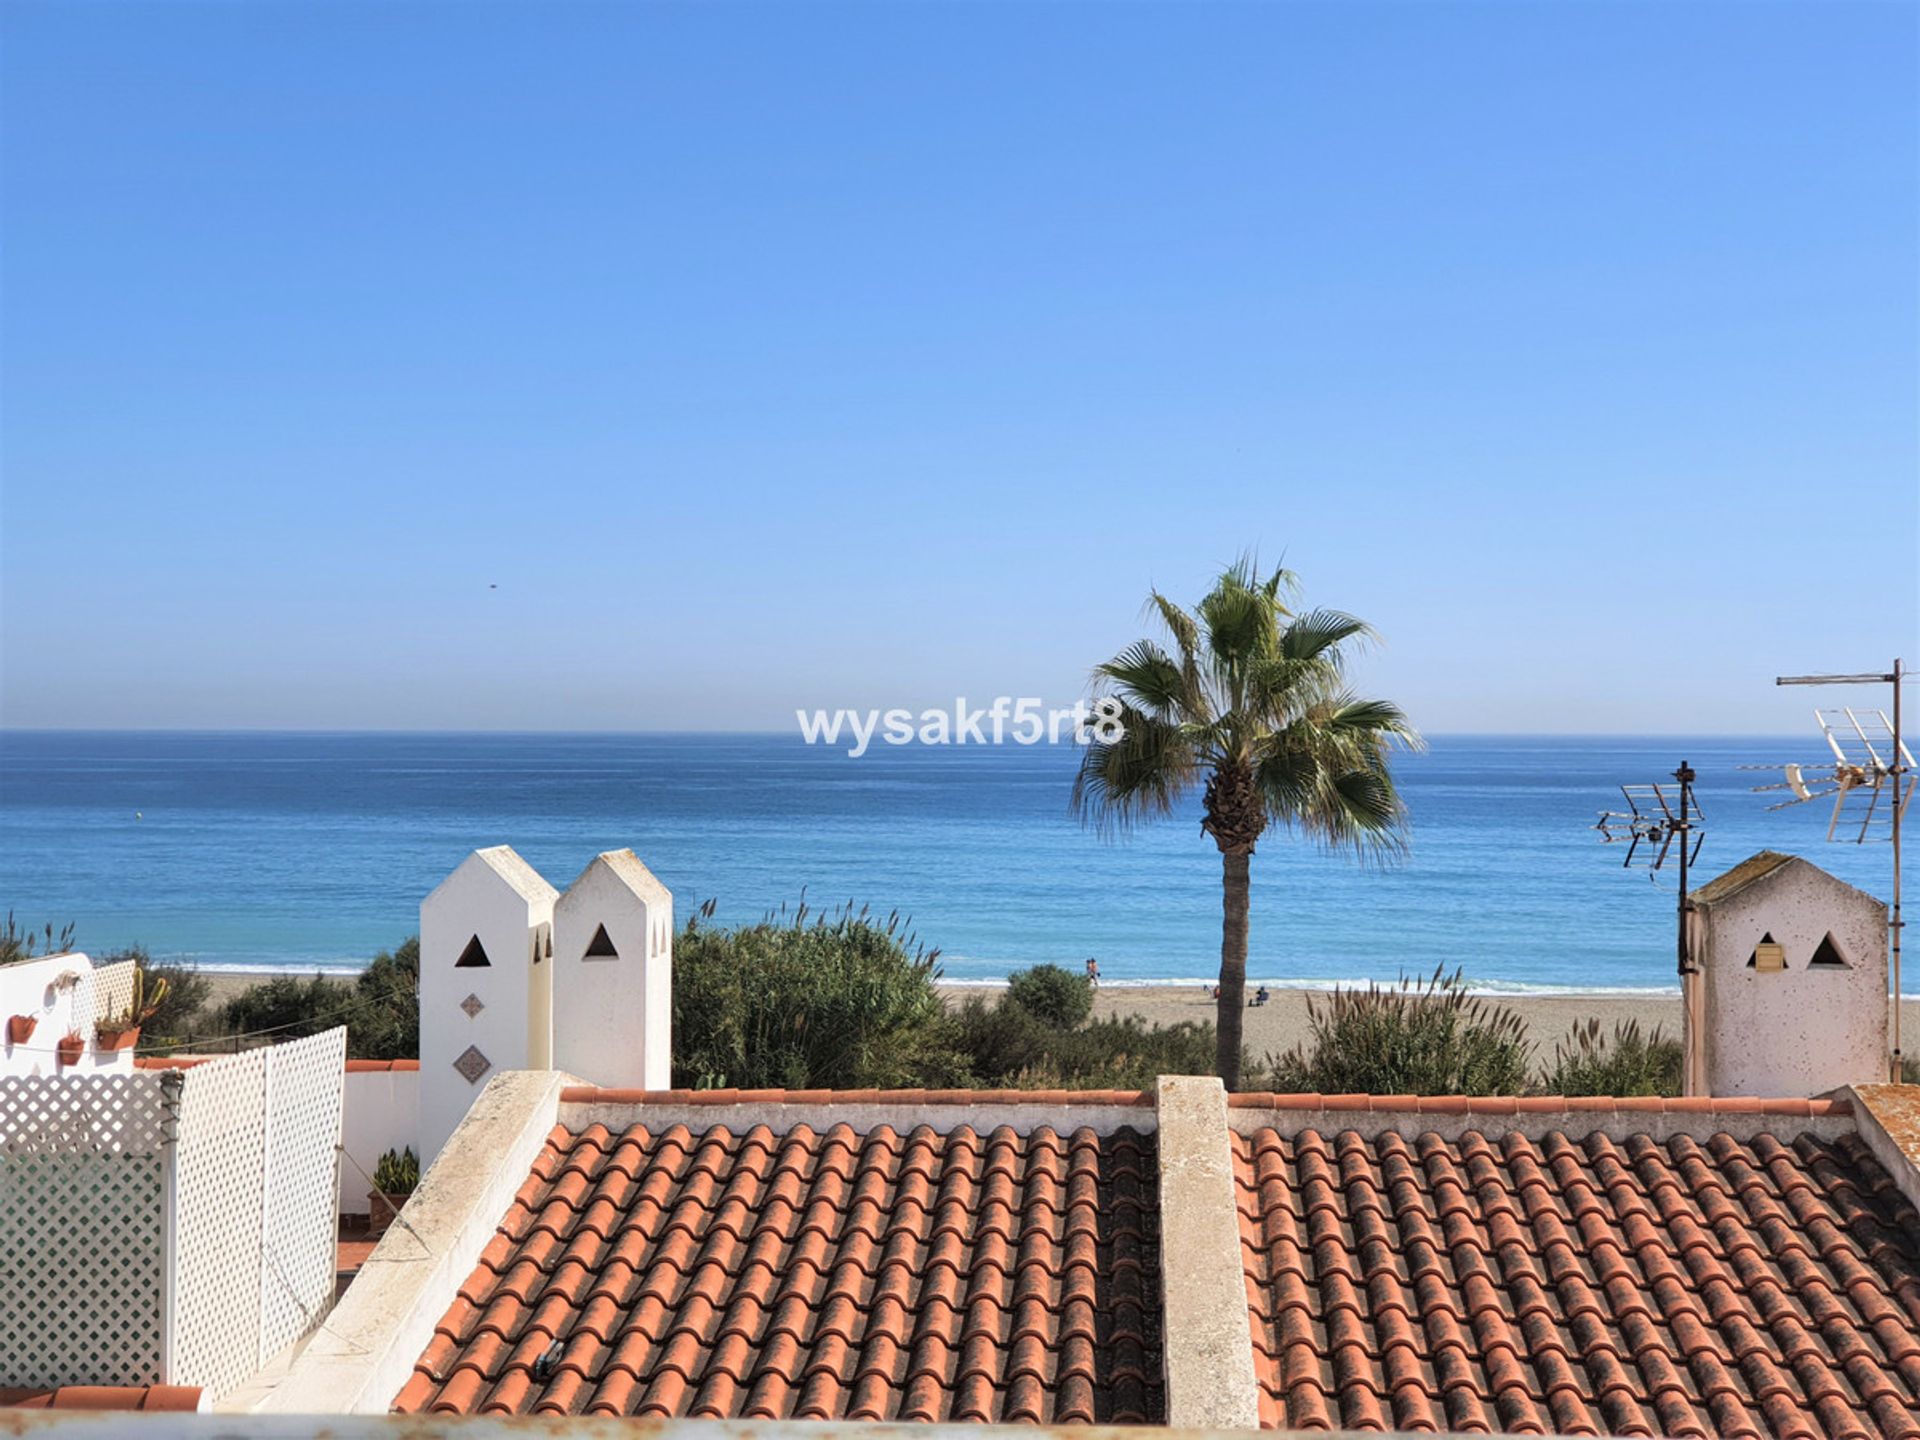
[167,1029,346,1392]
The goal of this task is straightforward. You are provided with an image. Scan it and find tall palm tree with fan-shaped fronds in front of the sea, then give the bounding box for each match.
[1073,559,1421,1091]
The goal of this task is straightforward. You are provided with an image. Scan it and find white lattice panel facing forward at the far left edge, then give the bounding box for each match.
[0,1073,165,1386]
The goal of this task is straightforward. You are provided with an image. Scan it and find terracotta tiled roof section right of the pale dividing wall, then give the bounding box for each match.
[1233,1128,1920,1436]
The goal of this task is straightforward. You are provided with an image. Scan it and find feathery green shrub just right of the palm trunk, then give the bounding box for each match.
[1267,970,1532,1094]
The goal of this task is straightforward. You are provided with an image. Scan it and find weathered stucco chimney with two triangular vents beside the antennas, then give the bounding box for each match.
[1688,851,1887,1096]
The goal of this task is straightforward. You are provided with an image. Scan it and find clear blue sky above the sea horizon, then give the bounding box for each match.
[0,0,1920,733]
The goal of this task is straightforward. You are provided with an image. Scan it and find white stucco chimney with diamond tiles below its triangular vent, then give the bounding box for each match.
[419,845,559,1165]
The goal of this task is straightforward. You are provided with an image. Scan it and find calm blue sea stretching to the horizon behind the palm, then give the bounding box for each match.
[0,730,1891,993]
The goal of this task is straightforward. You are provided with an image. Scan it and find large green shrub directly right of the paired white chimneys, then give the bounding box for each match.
[674,902,962,1089]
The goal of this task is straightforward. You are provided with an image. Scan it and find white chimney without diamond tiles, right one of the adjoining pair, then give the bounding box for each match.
[553,851,674,1091]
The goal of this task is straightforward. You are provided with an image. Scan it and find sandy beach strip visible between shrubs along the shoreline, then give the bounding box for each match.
[191,970,1920,1058]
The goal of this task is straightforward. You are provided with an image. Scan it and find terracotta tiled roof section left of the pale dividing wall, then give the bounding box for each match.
[396,1113,1165,1423]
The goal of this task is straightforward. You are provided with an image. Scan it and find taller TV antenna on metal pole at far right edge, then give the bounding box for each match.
[1741,660,1914,1083]
